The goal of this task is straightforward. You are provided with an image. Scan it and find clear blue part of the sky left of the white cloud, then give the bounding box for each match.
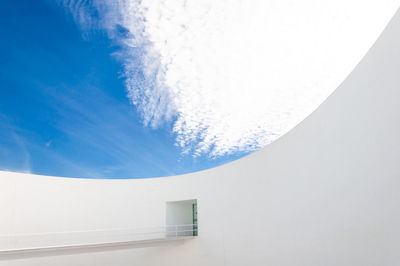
[0,0,245,178]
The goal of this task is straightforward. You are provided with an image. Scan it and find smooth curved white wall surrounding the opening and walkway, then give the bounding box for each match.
[0,8,400,266]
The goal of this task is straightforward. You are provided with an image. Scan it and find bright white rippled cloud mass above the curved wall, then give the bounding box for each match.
[64,0,400,157]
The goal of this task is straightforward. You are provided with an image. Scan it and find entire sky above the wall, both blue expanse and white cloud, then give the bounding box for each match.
[0,0,392,178]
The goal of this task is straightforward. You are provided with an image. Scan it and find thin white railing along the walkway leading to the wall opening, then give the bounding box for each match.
[0,224,197,254]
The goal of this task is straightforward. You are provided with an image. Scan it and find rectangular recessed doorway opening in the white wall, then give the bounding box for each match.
[166,199,198,236]
